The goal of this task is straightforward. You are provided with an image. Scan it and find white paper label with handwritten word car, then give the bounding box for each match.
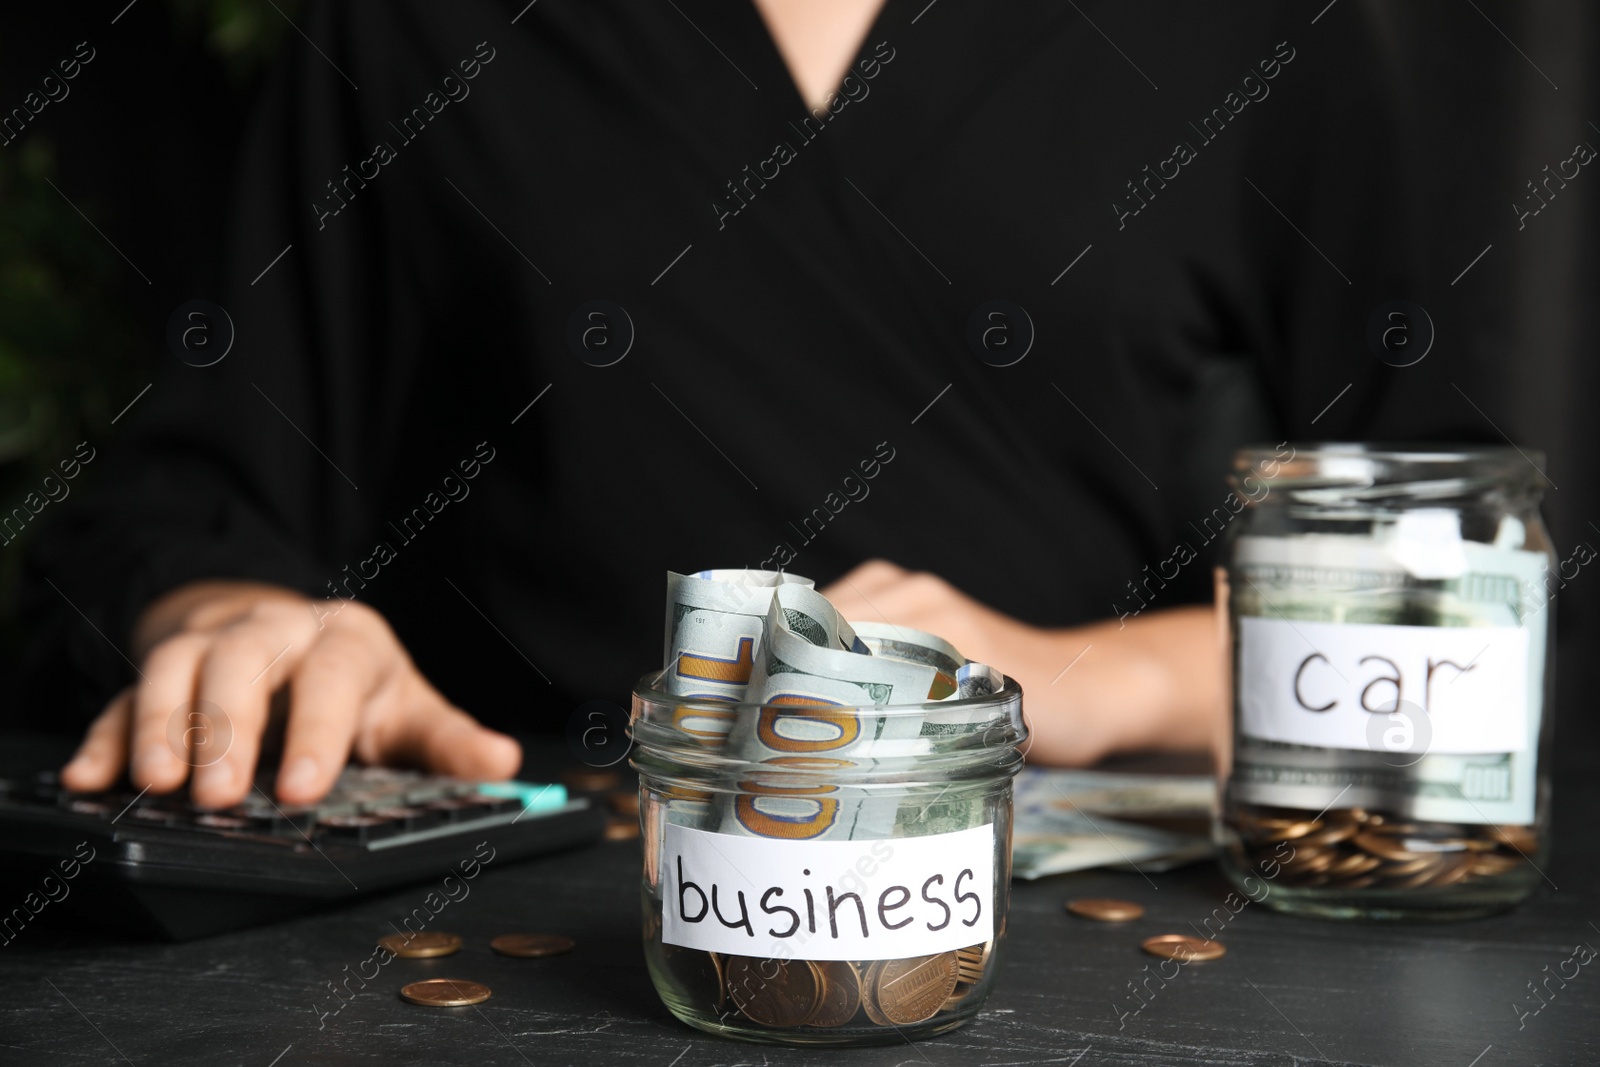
[1238,617,1528,755]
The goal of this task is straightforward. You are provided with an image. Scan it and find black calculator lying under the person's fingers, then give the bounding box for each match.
[0,766,606,941]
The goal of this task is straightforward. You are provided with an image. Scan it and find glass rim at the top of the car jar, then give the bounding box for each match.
[1232,442,1550,493]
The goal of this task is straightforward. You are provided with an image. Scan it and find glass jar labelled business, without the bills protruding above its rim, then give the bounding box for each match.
[632,677,1027,1045]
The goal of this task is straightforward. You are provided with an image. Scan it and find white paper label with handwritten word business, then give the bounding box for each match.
[661,822,995,960]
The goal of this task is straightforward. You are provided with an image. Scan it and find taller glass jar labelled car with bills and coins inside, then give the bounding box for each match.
[1216,445,1554,918]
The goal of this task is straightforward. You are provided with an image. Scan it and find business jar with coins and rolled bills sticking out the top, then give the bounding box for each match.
[630,571,1027,1045]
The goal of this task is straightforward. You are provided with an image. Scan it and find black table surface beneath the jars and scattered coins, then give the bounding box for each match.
[0,742,1600,1067]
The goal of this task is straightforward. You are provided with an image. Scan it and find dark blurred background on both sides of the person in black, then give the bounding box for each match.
[0,0,1600,751]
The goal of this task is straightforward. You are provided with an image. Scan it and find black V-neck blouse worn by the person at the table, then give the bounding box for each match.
[37,0,1426,729]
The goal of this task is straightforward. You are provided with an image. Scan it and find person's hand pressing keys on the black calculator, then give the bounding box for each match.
[61,581,522,808]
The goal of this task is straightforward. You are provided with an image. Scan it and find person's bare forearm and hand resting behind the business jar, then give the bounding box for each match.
[822,560,1222,766]
